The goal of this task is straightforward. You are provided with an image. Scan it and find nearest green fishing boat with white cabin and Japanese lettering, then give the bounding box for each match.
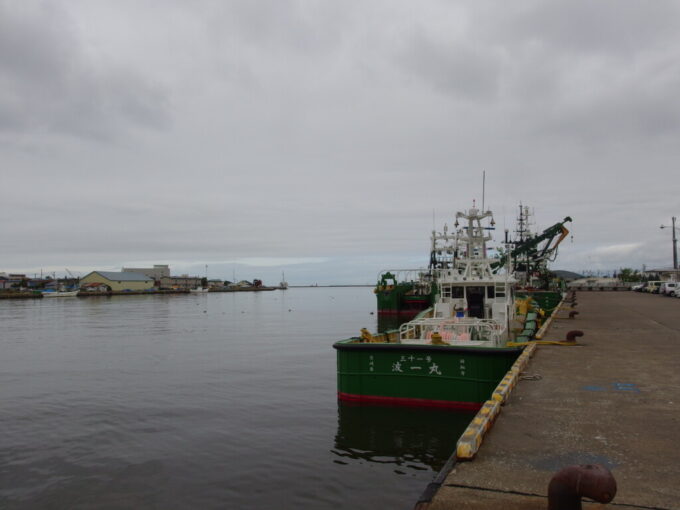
[333,205,564,411]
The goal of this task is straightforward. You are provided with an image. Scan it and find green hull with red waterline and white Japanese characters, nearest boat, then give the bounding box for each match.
[333,339,522,411]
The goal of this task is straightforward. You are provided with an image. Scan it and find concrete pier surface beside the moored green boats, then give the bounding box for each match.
[418,292,680,510]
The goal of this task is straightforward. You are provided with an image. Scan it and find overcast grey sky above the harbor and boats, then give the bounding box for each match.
[0,0,680,284]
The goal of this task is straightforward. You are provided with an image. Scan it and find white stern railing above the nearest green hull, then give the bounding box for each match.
[399,317,505,345]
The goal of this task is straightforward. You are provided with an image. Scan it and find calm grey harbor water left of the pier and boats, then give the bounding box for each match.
[0,288,470,509]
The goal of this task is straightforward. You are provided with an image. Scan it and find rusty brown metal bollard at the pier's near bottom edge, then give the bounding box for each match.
[548,464,616,510]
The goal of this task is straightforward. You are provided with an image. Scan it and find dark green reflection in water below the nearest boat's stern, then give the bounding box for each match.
[332,402,473,474]
